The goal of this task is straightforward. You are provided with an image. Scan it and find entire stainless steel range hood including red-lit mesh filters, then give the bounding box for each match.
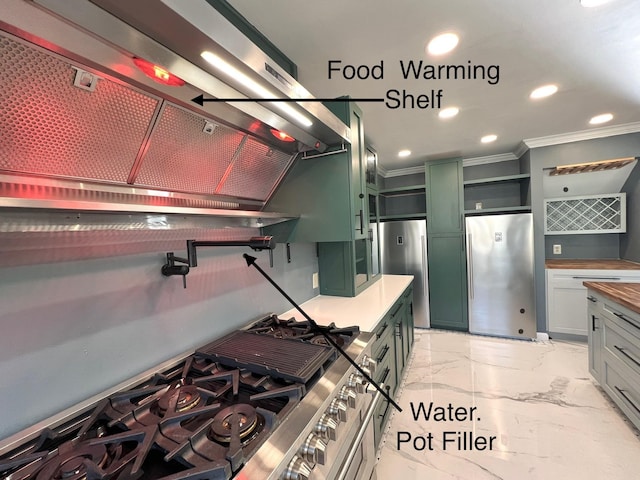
[0,0,350,219]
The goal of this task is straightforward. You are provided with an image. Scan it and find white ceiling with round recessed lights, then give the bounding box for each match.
[229,0,640,170]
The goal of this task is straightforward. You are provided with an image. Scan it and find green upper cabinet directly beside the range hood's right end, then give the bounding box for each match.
[264,97,369,242]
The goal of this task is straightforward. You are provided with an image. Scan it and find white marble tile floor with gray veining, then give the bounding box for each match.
[376,330,640,480]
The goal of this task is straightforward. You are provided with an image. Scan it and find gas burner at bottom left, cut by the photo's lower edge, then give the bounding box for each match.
[36,445,110,480]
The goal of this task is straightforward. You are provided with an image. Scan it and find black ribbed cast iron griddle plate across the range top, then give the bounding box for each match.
[196,331,336,384]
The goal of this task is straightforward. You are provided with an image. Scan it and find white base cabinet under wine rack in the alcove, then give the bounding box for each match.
[546,268,640,339]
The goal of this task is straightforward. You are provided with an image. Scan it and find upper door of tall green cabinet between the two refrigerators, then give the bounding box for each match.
[426,159,464,234]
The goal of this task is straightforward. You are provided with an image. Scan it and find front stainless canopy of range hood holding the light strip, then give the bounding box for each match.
[27,0,349,151]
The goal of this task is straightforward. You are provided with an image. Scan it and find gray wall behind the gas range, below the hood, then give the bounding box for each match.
[0,244,318,439]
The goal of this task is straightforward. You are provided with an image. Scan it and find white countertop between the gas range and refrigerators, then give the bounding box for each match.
[279,275,413,332]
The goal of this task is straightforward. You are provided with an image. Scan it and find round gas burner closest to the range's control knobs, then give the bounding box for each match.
[211,403,264,444]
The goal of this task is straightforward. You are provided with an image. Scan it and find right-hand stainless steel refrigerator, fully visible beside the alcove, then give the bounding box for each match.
[466,213,536,339]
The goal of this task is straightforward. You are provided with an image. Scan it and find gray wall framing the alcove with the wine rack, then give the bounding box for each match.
[525,133,640,332]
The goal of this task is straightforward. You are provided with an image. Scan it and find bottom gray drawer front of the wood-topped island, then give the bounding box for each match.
[602,352,640,428]
